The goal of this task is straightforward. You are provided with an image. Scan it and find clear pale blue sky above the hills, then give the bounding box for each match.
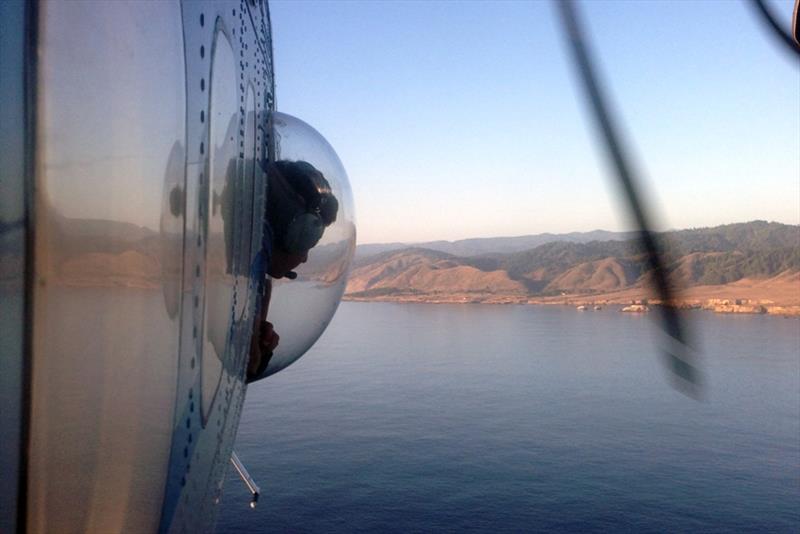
[270,0,800,243]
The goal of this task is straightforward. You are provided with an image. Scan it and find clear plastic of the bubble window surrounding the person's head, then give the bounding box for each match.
[265,112,356,382]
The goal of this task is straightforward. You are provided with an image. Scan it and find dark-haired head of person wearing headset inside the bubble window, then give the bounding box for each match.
[267,161,339,278]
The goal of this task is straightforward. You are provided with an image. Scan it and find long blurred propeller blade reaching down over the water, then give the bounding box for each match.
[554,0,701,396]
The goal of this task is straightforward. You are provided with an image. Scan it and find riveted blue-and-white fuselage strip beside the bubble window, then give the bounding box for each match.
[160,1,273,532]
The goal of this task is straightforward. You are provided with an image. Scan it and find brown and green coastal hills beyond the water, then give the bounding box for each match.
[346,221,800,312]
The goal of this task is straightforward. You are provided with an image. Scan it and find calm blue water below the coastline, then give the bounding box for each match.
[217,303,800,532]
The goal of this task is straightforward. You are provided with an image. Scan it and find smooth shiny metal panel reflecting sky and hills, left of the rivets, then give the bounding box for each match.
[28,2,186,532]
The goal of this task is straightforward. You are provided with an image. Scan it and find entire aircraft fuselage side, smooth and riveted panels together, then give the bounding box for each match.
[10,0,274,532]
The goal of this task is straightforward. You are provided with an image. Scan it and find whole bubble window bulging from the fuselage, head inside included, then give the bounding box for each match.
[266,113,356,376]
